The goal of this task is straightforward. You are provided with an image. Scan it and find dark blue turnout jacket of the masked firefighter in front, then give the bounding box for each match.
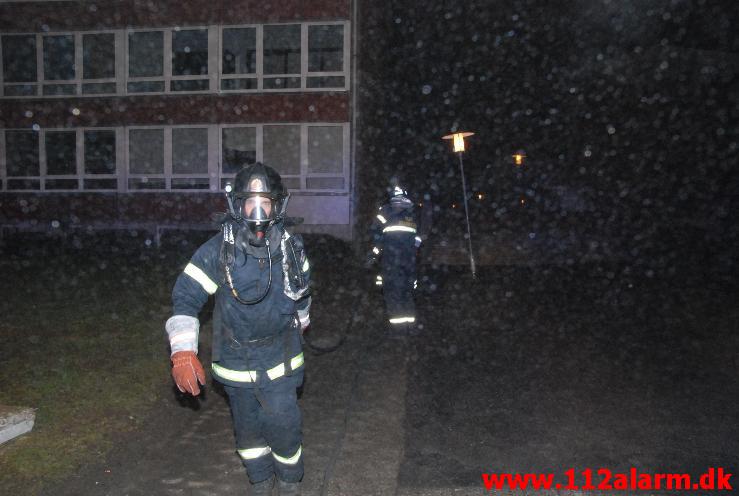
[166,224,311,389]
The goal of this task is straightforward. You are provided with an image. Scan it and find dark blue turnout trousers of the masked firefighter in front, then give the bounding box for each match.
[224,381,303,484]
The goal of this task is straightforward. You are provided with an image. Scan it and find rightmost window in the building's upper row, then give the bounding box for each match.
[307,24,345,88]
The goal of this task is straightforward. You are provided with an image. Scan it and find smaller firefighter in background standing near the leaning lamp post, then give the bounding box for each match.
[370,186,421,335]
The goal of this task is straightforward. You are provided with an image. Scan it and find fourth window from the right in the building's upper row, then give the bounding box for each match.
[170,29,210,91]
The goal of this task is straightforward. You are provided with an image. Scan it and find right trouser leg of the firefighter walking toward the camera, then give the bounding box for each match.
[260,386,303,482]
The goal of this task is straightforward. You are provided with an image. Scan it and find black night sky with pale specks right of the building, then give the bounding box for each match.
[359,0,739,268]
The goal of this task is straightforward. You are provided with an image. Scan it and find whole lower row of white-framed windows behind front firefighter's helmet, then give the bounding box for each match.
[0,123,349,192]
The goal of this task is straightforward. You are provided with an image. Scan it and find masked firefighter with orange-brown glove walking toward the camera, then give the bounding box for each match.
[166,163,311,496]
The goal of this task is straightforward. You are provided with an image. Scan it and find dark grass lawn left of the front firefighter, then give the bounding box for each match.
[0,233,211,495]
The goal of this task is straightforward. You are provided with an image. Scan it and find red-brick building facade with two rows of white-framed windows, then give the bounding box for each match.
[0,0,355,239]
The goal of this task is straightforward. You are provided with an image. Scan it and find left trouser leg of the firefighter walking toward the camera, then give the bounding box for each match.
[224,386,274,483]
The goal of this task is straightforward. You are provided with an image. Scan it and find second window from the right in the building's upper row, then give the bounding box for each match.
[264,24,300,90]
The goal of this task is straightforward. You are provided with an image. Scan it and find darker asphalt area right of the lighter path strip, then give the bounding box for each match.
[398,265,739,495]
